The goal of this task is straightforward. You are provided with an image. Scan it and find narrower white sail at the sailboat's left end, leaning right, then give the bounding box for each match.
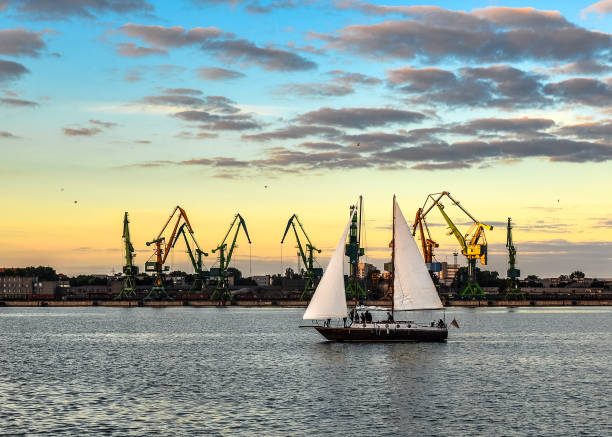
[302,209,357,319]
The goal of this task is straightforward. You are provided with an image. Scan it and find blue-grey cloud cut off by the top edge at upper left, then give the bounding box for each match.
[8,0,154,20]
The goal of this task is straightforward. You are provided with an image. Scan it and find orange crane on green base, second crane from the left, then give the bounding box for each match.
[145,205,193,300]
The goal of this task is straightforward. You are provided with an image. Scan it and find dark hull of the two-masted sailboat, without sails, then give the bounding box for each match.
[314,324,448,342]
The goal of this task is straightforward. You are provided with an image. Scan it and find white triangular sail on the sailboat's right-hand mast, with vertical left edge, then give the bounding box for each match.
[393,199,442,311]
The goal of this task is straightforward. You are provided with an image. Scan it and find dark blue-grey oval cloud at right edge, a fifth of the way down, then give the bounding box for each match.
[544,78,612,106]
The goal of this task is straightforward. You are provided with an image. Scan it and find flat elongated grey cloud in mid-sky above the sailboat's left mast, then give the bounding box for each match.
[297,107,425,129]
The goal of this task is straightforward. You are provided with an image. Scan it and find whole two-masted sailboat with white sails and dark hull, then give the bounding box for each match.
[302,196,448,342]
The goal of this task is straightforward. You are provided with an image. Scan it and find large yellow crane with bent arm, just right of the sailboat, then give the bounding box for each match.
[422,191,493,296]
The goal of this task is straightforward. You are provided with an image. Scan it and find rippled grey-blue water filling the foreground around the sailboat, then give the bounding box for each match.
[0,307,612,436]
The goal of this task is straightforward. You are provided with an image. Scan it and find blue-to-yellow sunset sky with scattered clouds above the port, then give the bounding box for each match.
[0,0,612,277]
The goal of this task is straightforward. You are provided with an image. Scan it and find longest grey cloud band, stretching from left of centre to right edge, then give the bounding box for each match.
[124,135,612,175]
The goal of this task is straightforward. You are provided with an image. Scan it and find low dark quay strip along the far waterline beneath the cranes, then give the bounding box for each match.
[0,299,612,308]
